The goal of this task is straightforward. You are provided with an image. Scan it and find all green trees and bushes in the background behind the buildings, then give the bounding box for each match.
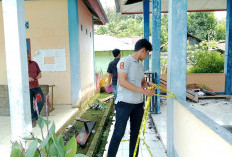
[95,8,226,73]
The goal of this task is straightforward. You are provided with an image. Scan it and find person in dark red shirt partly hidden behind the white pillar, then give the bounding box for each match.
[27,53,44,127]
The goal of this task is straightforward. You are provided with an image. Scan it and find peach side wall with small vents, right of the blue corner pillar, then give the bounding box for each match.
[78,0,95,101]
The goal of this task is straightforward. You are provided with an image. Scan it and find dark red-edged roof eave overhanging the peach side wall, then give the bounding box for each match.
[83,0,108,25]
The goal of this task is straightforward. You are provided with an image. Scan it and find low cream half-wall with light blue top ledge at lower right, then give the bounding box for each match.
[173,100,232,157]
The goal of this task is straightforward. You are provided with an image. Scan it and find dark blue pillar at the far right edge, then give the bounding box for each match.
[224,0,232,95]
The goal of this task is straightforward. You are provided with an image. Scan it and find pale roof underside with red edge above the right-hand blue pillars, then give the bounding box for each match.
[115,0,227,14]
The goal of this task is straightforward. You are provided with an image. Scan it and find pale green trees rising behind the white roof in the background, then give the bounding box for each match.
[95,8,168,44]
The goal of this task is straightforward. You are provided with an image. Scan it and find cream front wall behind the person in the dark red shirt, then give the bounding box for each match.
[0,0,71,104]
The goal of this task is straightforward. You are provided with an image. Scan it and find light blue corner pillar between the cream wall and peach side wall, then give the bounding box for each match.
[68,0,81,106]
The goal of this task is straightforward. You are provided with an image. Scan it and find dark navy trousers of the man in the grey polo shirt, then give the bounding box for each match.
[108,102,144,157]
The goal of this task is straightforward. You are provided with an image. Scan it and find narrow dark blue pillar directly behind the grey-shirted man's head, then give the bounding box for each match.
[143,0,150,71]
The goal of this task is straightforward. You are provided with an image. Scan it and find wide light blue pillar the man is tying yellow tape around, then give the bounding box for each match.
[167,0,187,157]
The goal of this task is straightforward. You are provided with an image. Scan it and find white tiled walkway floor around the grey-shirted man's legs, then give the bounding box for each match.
[103,116,167,157]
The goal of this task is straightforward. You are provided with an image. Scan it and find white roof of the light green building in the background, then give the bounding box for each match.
[94,35,134,51]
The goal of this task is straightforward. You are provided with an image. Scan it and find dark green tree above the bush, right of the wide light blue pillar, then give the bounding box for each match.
[188,12,217,41]
